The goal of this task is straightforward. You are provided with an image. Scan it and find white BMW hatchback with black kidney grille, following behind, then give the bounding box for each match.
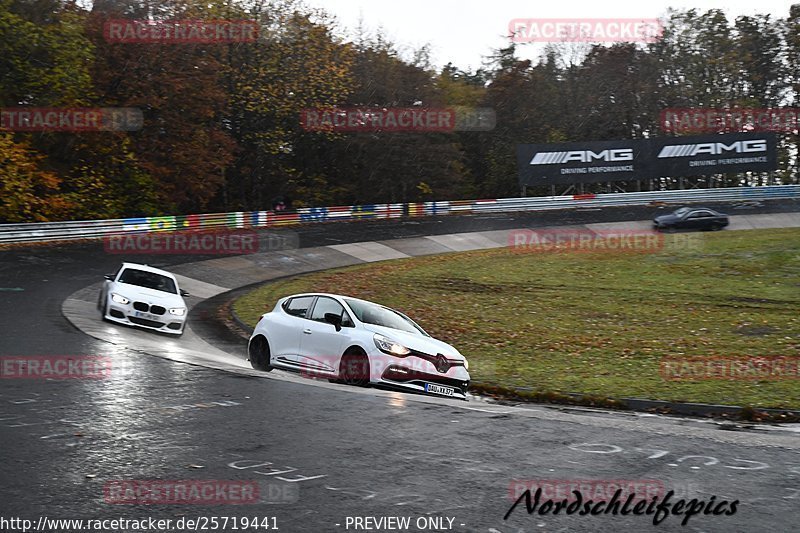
[97,263,189,335]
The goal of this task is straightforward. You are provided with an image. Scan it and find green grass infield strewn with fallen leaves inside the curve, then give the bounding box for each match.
[234,229,800,409]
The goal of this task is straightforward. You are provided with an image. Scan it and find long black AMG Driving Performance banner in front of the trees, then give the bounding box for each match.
[517,132,777,186]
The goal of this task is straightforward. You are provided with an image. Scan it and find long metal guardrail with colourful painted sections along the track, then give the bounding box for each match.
[0,185,800,243]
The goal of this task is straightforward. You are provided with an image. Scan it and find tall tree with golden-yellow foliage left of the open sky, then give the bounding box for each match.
[226,3,353,209]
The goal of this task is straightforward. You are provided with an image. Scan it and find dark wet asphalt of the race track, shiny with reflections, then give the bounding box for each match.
[0,201,800,533]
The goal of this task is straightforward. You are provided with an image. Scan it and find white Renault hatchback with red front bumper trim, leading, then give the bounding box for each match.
[248,294,470,400]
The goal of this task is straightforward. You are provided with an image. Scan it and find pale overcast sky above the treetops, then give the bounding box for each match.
[306,0,796,70]
